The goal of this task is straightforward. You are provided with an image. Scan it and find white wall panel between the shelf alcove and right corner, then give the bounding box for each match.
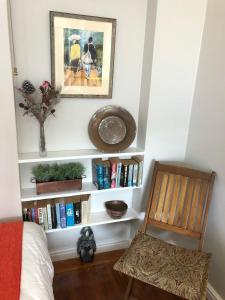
[141,0,206,209]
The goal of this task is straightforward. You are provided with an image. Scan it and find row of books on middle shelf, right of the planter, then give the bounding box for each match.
[92,156,143,190]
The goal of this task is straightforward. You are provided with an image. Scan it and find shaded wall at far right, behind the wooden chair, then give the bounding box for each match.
[186,0,225,299]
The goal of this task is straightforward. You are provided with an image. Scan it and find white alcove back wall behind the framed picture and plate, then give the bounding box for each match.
[12,0,147,152]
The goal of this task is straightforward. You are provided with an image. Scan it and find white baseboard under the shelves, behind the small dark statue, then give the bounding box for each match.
[49,240,130,261]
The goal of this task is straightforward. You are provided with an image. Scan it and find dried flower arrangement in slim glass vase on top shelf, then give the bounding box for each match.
[18,80,60,156]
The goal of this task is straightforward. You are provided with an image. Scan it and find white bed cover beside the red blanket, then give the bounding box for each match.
[20,222,54,300]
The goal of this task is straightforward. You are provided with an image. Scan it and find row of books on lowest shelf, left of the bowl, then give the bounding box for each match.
[23,195,90,230]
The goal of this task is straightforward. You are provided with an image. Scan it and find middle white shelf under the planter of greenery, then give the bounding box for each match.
[21,182,142,202]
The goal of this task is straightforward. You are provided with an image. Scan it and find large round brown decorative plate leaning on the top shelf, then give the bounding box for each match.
[88,105,136,152]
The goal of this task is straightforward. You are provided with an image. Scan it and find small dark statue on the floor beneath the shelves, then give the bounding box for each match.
[77,226,96,263]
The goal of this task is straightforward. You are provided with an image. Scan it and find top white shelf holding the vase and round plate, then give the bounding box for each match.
[19,147,145,164]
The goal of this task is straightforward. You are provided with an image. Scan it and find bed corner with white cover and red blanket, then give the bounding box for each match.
[0,222,54,300]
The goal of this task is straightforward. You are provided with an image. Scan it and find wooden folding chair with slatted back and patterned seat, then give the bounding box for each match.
[114,162,215,300]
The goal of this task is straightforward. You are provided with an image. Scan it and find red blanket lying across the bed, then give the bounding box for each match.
[0,221,23,300]
